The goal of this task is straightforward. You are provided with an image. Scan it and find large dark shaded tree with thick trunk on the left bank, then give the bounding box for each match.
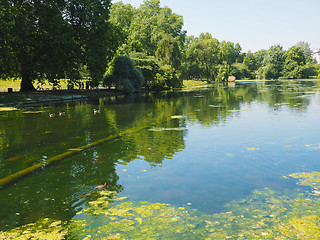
[0,0,110,91]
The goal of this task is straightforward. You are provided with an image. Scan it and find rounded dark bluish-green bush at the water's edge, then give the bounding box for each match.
[105,56,144,93]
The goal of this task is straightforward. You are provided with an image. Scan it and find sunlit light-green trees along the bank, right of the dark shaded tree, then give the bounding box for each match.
[110,0,319,89]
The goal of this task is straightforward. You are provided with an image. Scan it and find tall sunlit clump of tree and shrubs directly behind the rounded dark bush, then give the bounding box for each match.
[110,0,186,90]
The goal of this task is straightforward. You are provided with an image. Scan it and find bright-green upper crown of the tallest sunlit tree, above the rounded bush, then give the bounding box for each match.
[116,0,186,56]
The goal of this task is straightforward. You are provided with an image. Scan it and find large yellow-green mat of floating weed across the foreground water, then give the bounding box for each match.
[4,172,320,240]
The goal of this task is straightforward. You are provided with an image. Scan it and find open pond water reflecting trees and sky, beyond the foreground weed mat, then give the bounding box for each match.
[0,81,320,229]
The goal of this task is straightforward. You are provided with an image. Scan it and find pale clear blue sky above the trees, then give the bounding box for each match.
[113,0,320,52]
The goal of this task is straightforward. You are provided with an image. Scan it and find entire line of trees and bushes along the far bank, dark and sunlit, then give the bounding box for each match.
[0,0,319,92]
